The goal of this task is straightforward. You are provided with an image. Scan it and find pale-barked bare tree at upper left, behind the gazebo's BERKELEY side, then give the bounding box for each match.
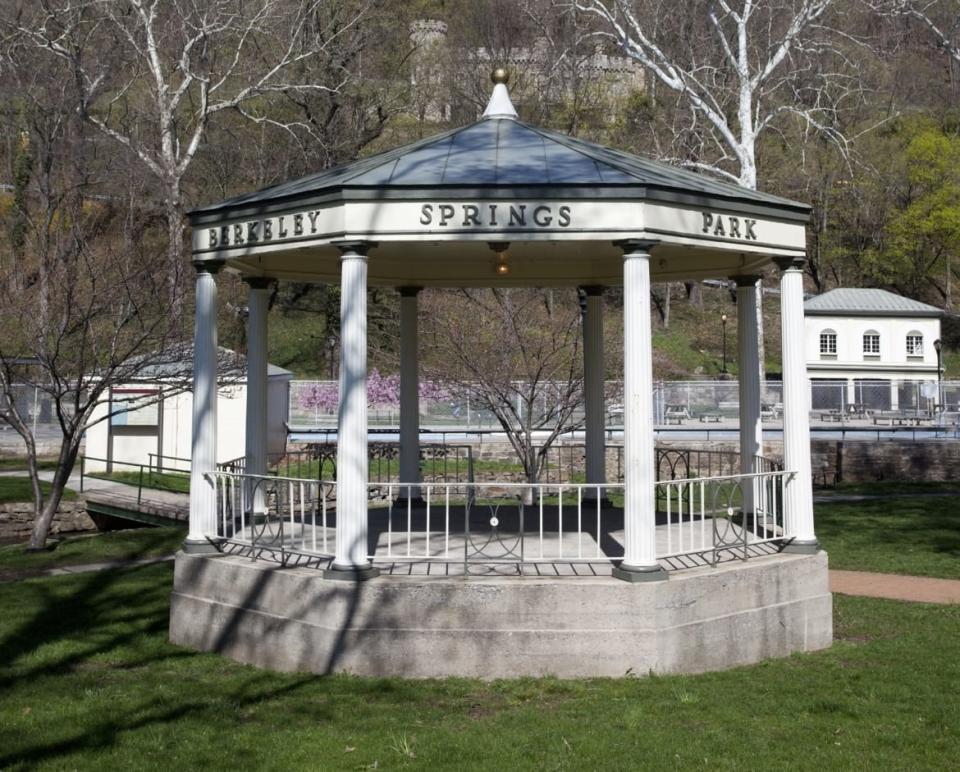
[3,0,382,308]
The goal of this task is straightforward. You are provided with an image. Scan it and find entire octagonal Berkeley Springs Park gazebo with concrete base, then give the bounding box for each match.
[171,71,832,677]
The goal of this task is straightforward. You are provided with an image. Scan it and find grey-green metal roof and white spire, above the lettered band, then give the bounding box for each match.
[190,97,810,225]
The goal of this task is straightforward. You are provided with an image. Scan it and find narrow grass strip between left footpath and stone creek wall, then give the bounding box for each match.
[0,526,186,578]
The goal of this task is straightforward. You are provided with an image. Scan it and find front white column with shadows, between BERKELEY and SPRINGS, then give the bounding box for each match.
[324,242,379,579]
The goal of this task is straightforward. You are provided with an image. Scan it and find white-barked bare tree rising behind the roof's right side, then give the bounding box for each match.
[574,0,868,375]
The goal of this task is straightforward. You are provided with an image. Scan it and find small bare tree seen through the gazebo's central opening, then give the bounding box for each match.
[424,289,583,494]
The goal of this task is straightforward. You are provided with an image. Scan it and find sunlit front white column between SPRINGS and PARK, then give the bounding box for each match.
[613,241,667,582]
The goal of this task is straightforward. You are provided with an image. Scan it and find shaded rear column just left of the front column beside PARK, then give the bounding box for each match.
[582,287,607,499]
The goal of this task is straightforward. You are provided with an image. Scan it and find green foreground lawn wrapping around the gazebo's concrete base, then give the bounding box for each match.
[0,565,960,770]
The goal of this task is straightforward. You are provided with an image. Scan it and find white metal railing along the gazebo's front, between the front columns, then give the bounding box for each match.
[211,471,793,569]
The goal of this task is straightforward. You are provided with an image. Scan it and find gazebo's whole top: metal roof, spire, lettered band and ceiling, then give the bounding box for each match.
[190,76,810,287]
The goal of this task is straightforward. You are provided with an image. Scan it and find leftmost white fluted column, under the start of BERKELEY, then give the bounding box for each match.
[183,262,223,553]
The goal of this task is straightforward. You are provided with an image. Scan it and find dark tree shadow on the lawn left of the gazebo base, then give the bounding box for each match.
[0,540,329,769]
